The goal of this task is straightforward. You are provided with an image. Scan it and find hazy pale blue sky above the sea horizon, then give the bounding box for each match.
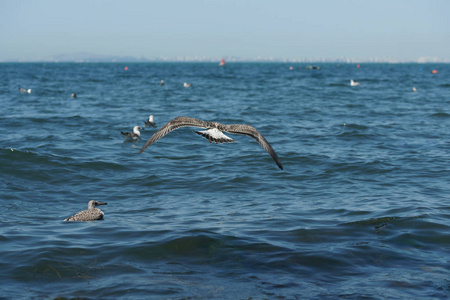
[0,0,450,61]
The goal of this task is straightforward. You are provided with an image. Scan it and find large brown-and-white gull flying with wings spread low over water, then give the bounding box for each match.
[139,117,283,170]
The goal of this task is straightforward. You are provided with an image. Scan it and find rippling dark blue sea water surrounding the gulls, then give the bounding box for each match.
[0,63,450,299]
